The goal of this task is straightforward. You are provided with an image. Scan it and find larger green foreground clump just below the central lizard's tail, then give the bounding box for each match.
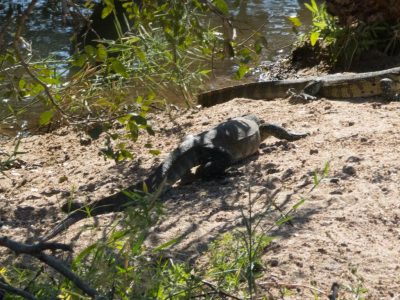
[55,191,205,299]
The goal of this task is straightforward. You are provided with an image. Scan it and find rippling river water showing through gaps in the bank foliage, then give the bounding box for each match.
[0,0,311,135]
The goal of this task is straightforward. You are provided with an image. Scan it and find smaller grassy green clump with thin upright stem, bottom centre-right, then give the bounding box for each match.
[207,189,304,299]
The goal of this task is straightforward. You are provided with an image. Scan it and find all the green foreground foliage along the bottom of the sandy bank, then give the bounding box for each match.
[0,163,376,299]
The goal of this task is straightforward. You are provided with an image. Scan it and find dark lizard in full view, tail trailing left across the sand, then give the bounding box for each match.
[44,115,308,240]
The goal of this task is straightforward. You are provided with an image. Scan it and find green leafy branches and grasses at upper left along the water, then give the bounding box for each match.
[0,0,262,162]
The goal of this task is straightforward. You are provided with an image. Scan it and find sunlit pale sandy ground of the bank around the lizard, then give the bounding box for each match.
[0,99,400,299]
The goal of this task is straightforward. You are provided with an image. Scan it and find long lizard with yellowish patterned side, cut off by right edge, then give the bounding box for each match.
[198,67,400,107]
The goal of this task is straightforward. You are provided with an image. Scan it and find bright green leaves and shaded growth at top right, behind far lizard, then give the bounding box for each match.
[289,0,400,68]
